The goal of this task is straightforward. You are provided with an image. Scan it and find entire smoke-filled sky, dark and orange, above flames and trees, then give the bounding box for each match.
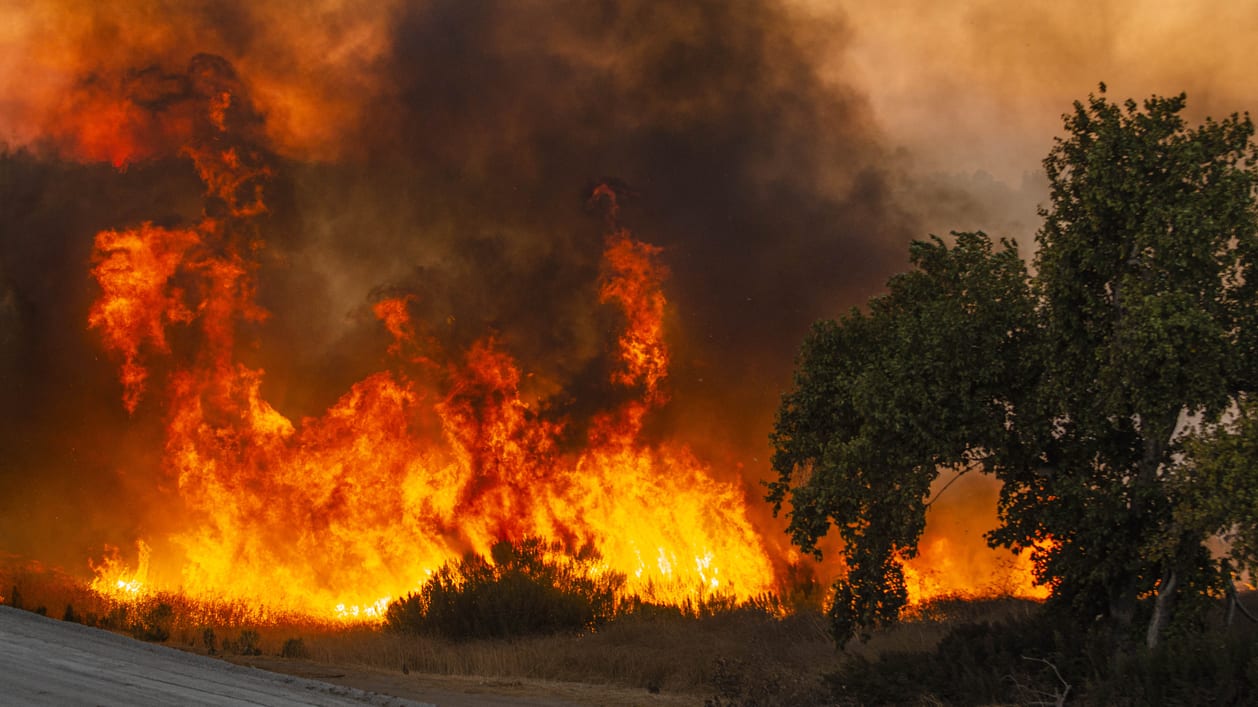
[0,0,1258,568]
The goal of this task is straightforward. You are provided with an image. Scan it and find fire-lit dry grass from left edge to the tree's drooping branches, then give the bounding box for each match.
[7,556,834,697]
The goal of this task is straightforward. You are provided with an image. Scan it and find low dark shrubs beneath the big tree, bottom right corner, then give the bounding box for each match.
[827,598,1258,707]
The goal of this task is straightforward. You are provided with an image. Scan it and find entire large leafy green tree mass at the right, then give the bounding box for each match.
[767,86,1258,644]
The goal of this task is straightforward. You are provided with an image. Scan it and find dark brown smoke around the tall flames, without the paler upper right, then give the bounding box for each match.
[0,0,925,559]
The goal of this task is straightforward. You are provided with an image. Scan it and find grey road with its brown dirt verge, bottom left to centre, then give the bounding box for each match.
[0,598,693,707]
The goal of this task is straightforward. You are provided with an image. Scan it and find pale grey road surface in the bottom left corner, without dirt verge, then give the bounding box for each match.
[0,606,425,707]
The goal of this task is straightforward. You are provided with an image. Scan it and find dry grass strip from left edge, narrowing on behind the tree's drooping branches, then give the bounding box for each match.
[0,558,1051,704]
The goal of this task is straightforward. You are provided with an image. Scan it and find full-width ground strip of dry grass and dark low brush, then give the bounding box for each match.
[12,548,1258,707]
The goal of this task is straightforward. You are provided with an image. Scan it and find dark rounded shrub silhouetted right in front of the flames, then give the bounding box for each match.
[386,538,624,639]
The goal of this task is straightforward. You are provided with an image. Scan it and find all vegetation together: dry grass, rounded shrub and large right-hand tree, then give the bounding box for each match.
[7,87,1258,707]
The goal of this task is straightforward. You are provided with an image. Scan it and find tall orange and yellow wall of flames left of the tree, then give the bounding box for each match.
[89,72,774,618]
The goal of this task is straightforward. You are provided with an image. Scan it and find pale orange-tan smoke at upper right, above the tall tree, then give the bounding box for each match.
[835,0,1258,253]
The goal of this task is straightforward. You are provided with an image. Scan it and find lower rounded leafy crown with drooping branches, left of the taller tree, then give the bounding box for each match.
[767,233,1034,642]
